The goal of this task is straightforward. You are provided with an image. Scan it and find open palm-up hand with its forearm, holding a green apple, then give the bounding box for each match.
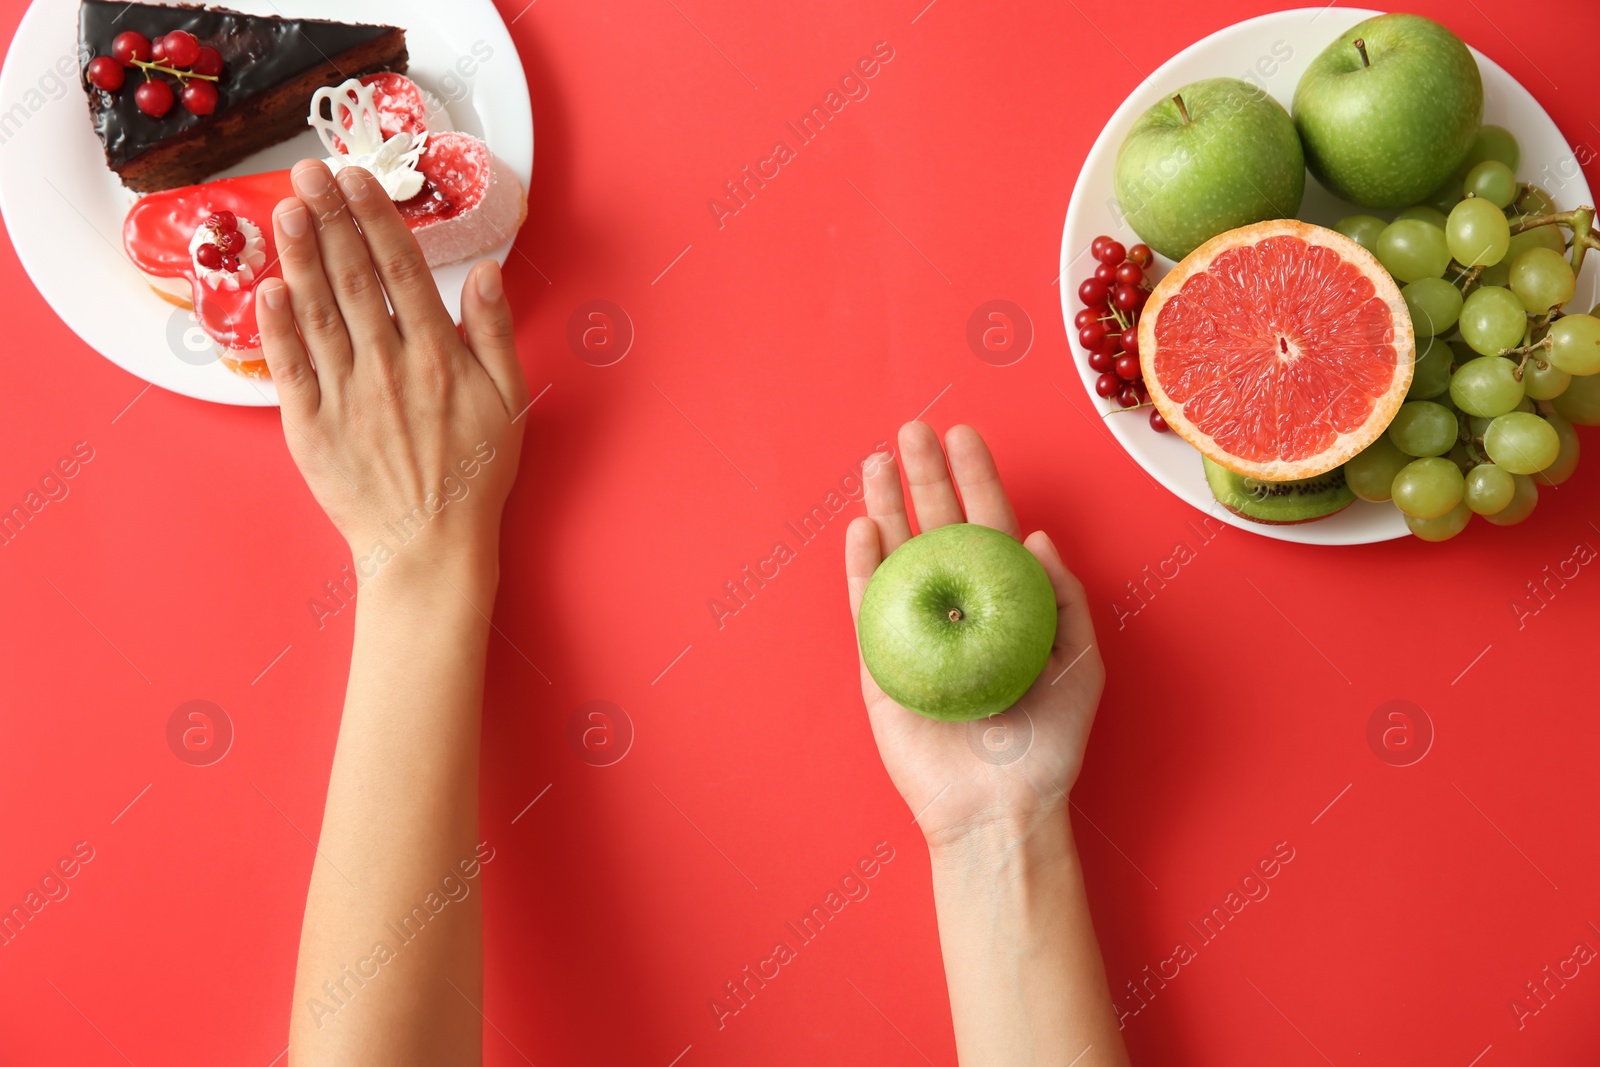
[845,422,1128,1067]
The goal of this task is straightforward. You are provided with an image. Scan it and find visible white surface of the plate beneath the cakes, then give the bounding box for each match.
[0,0,533,406]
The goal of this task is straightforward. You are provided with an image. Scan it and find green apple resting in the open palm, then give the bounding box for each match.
[858,523,1056,721]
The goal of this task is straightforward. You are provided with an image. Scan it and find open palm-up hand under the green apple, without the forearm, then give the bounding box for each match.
[845,422,1106,846]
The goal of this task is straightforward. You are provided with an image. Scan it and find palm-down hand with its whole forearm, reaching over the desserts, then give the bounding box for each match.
[256,162,528,1067]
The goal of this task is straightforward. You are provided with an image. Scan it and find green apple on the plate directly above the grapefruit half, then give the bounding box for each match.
[1115,78,1306,259]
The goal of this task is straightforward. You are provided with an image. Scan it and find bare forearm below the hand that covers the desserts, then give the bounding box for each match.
[290,561,494,1065]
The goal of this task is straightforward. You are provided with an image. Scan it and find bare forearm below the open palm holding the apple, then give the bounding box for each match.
[931,813,1128,1067]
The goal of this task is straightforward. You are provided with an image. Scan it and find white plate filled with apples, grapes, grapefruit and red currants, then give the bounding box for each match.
[1061,8,1600,544]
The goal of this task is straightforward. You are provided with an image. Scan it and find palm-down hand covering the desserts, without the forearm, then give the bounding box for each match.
[256,160,528,582]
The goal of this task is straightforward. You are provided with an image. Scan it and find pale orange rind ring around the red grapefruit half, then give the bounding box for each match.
[1139,219,1416,482]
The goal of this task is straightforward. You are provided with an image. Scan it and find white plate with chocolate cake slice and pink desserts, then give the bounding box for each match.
[0,0,533,406]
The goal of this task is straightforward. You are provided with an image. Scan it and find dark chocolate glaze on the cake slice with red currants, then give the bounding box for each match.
[78,0,405,170]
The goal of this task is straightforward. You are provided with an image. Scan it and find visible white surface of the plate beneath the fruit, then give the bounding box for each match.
[1061,8,1600,544]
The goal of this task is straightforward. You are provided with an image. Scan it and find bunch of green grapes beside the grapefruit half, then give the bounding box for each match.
[1334,126,1600,541]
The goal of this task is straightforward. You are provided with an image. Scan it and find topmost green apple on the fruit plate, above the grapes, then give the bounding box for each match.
[1294,13,1483,208]
